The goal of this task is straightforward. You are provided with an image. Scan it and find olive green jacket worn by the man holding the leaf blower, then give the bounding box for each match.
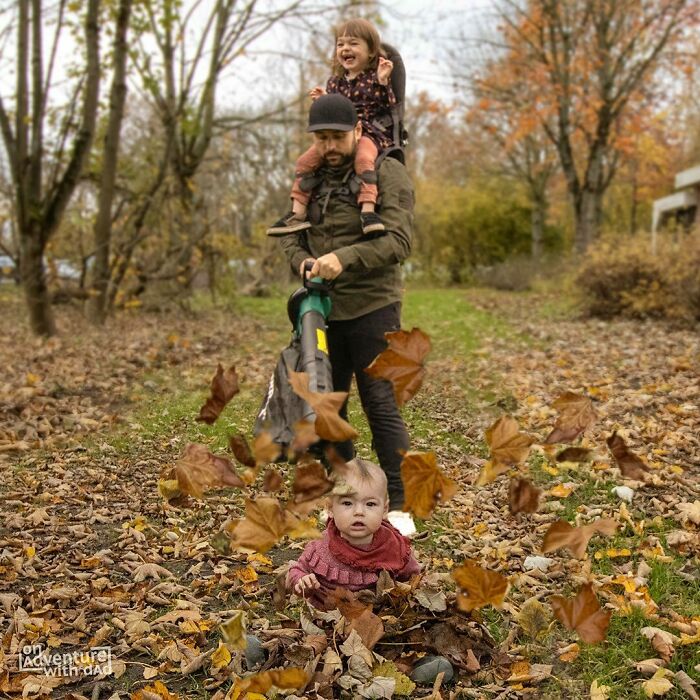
[280,158,414,321]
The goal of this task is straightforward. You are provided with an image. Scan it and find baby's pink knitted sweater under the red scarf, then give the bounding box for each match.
[287,526,420,603]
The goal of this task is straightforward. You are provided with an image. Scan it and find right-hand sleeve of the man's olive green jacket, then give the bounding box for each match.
[332,158,414,269]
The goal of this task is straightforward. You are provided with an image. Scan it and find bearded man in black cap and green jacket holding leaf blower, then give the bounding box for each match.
[280,94,416,535]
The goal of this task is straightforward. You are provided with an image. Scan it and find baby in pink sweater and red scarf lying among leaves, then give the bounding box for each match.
[287,459,420,608]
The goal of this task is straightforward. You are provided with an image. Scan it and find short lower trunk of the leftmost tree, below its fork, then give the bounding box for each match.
[20,227,56,336]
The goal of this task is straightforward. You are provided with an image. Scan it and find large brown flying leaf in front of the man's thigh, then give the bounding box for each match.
[365,328,431,406]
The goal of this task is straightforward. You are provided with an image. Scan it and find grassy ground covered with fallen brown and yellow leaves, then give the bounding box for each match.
[0,292,700,698]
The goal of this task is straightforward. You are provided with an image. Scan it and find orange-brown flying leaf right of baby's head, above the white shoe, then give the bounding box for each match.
[401,452,459,519]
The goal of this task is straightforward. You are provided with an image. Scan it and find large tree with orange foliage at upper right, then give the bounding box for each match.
[481,0,700,252]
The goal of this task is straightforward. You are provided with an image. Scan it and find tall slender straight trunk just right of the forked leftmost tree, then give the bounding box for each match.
[86,0,132,325]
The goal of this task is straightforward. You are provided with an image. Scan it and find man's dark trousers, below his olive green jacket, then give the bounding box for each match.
[328,302,409,510]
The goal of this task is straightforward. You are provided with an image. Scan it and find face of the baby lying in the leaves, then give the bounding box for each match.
[331,479,389,545]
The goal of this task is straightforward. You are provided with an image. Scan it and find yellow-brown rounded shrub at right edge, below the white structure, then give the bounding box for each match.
[576,236,700,320]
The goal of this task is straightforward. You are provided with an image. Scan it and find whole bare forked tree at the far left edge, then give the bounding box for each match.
[0,0,99,335]
